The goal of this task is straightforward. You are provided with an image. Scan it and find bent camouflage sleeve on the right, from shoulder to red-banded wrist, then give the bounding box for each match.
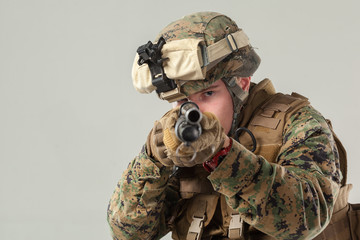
[208,107,342,239]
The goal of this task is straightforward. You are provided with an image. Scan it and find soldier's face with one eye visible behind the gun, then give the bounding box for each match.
[175,80,233,133]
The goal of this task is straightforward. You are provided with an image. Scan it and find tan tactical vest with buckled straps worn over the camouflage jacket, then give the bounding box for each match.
[169,79,360,240]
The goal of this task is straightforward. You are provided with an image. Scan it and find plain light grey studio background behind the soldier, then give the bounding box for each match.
[0,0,360,240]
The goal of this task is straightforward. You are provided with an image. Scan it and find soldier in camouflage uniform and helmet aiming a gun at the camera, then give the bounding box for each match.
[108,12,351,240]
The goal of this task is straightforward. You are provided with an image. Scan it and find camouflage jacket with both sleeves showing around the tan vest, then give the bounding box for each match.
[108,79,342,239]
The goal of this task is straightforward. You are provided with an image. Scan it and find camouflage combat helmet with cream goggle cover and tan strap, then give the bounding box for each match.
[132,12,260,102]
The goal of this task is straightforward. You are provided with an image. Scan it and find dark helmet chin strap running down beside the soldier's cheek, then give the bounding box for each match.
[221,76,249,137]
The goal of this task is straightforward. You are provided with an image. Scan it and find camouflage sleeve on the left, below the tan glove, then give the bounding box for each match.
[107,146,177,240]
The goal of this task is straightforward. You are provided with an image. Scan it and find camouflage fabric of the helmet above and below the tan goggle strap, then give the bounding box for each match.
[157,12,260,96]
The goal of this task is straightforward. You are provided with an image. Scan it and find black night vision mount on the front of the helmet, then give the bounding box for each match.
[136,37,177,94]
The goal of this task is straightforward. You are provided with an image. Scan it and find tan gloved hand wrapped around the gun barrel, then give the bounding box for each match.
[147,108,226,167]
